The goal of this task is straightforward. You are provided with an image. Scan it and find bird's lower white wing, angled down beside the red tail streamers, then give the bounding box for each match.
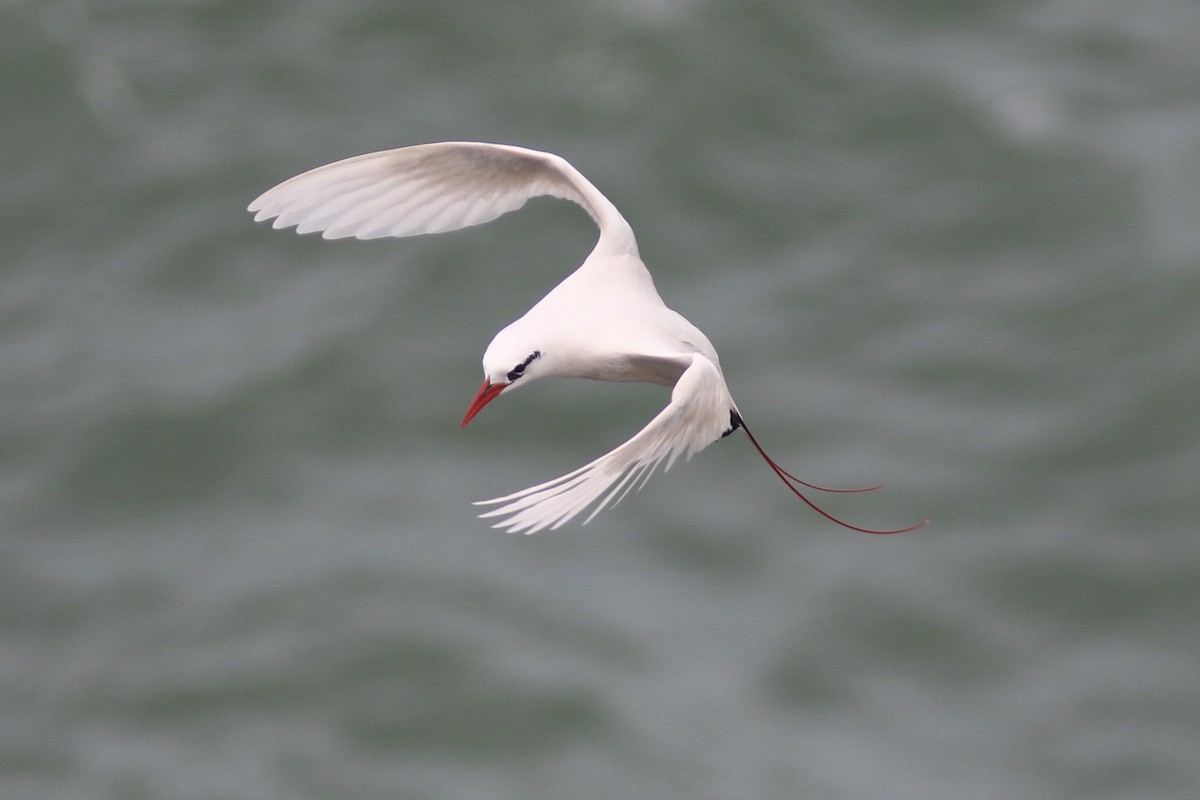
[475,353,734,534]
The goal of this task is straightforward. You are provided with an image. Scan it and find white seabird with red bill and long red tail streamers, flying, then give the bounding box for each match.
[248,142,928,534]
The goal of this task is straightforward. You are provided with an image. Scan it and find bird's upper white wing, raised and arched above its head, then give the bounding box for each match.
[248,142,632,248]
